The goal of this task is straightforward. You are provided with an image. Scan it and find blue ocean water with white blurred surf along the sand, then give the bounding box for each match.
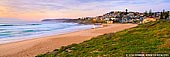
[0,22,93,44]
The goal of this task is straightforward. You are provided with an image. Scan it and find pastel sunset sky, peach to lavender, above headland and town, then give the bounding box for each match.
[0,0,170,20]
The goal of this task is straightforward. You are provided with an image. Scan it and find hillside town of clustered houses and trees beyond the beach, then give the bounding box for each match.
[70,9,170,24]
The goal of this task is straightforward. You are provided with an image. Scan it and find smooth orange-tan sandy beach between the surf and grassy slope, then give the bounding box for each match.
[0,24,137,57]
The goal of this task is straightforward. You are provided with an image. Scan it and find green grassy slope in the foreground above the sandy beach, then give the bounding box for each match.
[36,20,170,57]
